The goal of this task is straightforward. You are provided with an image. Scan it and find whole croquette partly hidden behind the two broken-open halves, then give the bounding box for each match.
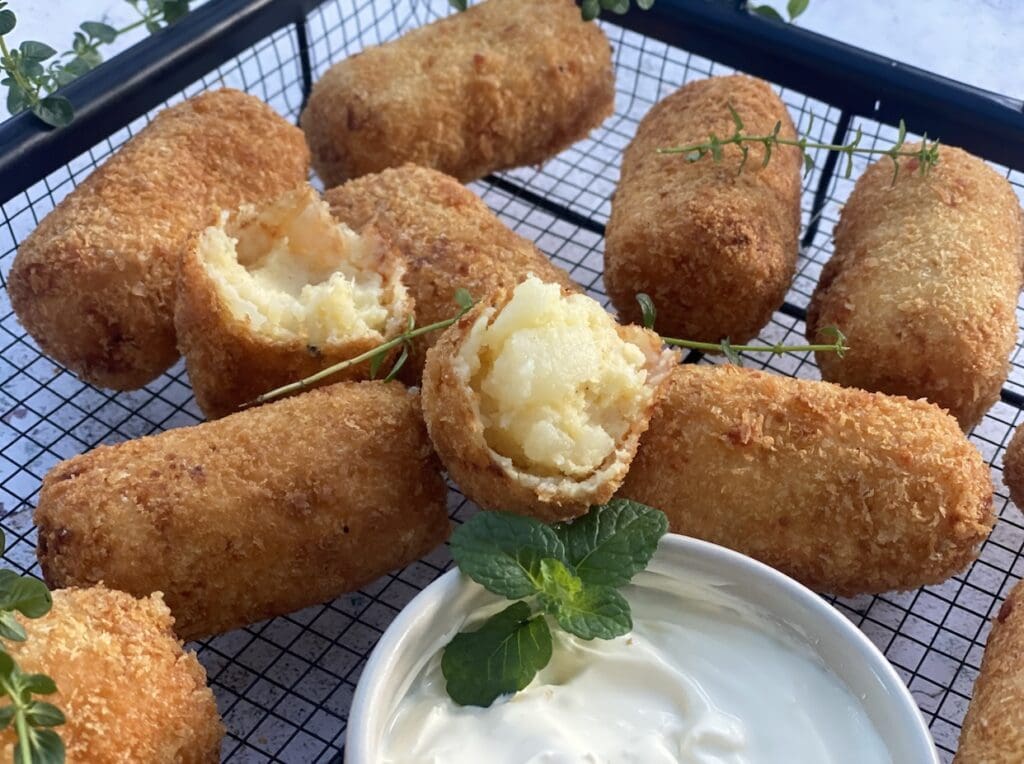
[325,165,579,374]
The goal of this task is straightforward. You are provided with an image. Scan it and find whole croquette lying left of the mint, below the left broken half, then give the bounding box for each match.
[36,382,449,639]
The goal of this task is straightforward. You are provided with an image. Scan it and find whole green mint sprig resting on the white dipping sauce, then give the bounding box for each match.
[441,499,669,707]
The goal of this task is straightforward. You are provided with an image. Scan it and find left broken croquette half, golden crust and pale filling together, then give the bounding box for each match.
[174,186,413,419]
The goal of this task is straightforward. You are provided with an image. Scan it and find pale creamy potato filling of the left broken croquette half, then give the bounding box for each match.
[200,188,391,345]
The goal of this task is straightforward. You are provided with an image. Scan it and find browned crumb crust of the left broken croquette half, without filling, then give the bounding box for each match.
[174,209,413,419]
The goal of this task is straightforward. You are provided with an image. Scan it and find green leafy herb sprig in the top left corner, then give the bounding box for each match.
[0,0,189,127]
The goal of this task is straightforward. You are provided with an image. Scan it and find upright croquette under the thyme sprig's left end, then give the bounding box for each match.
[604,75,802,342]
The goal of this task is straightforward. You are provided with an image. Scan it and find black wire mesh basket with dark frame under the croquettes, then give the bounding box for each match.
[0,0,1024,762]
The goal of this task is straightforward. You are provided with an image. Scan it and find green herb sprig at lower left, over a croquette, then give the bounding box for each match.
[0,532,65,764]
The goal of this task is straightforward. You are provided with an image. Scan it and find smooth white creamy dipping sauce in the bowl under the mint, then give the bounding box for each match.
[383,572,892,764]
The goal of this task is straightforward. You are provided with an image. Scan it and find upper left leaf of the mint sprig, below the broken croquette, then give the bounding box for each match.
[451,512,565,599]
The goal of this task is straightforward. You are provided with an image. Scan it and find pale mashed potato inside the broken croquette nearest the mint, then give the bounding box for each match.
[462,277,651,478]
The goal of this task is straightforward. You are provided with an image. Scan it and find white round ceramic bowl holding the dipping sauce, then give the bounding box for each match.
[345,534,939,764]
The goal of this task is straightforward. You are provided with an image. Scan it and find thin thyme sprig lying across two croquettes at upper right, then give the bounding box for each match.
[657,103,939,184]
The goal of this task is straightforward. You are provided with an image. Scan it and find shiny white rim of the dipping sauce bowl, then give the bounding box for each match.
[344,534,939,764]
